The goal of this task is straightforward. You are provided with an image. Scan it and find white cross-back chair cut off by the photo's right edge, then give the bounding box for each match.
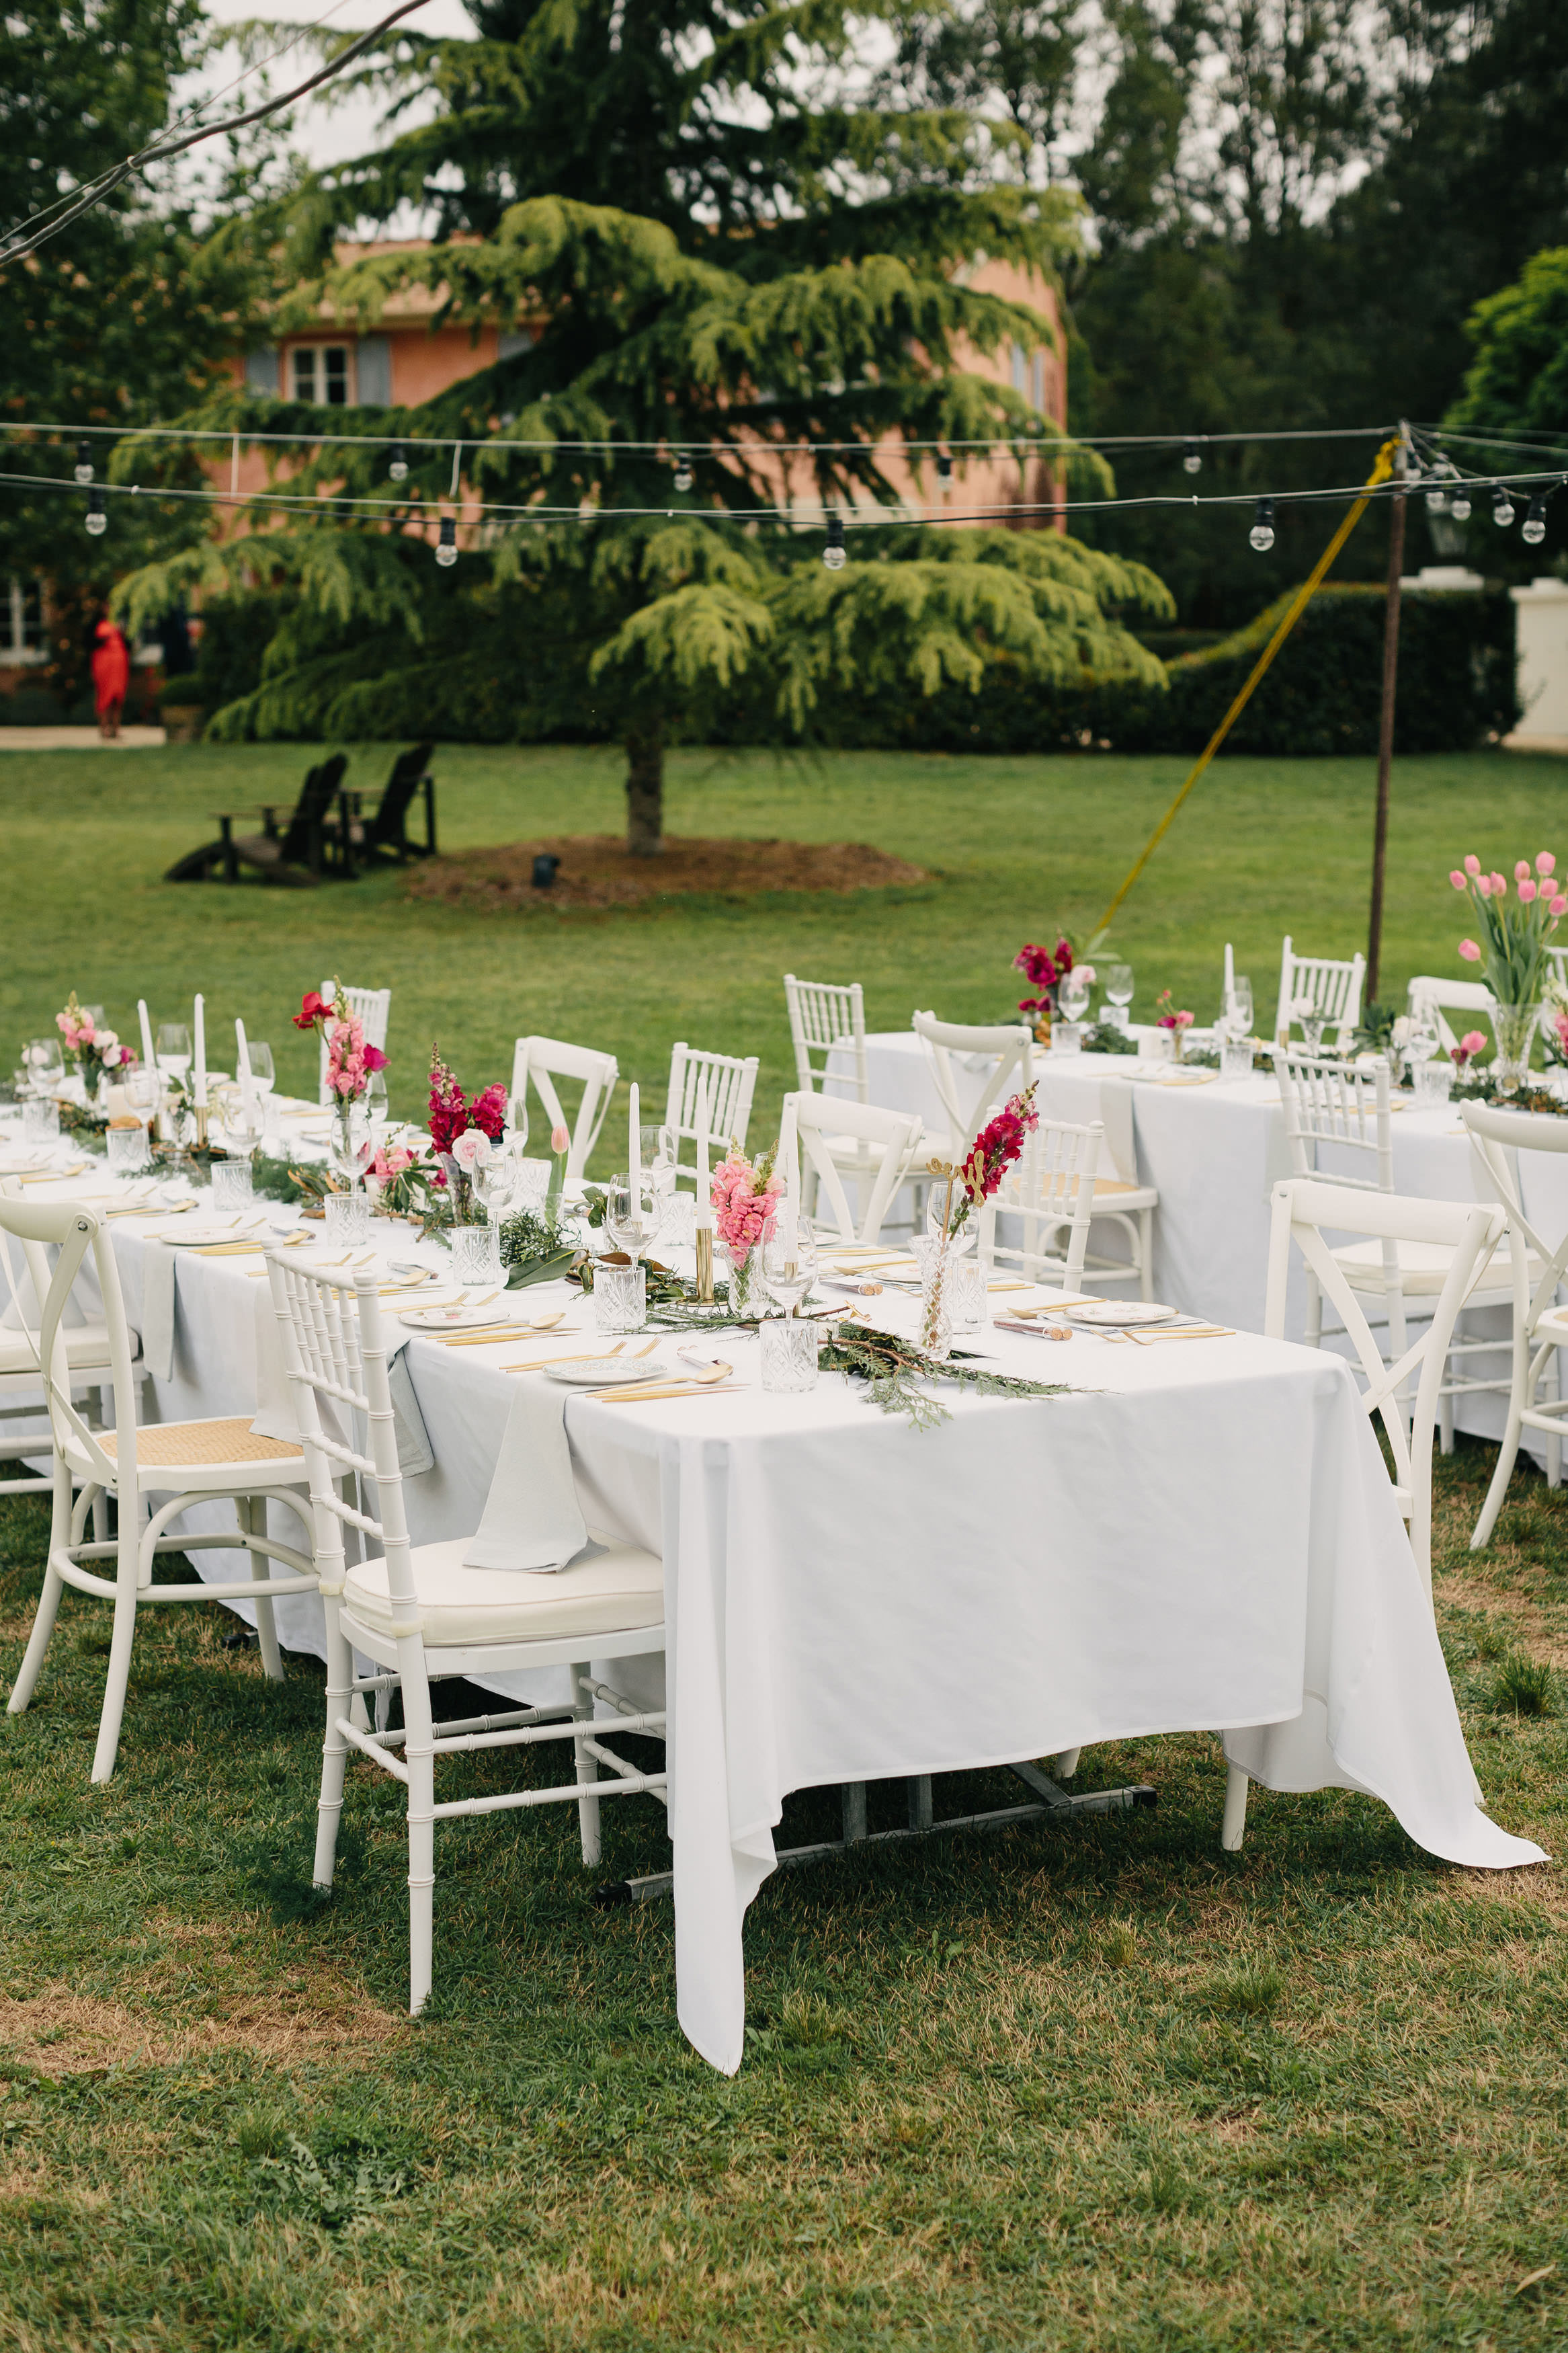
[1460,1104,1568,1553]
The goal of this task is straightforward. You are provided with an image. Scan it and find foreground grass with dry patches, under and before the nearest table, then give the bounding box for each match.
[0,1443,1568,2353]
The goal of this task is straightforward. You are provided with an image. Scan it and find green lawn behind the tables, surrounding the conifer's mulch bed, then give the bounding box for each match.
[0,746,1568,1151]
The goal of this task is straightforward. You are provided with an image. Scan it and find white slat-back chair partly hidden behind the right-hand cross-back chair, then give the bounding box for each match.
[1274,1047,1512,1454]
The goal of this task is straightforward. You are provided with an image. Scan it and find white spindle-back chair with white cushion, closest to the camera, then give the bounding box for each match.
[268,1252,667,2014]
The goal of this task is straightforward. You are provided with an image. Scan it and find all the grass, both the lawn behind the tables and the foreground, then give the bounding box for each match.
[0,748,1568,2353]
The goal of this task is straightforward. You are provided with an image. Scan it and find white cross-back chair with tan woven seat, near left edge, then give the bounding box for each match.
[0,1200,315,1782]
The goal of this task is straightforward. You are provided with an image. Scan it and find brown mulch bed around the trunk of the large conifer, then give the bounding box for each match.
[409,833,929,913]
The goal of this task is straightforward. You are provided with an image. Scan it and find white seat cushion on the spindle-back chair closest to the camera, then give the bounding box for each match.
[343,1537,665,1650]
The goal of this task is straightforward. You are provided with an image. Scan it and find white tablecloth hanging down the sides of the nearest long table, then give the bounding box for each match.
[0,1144,1542,2071]
